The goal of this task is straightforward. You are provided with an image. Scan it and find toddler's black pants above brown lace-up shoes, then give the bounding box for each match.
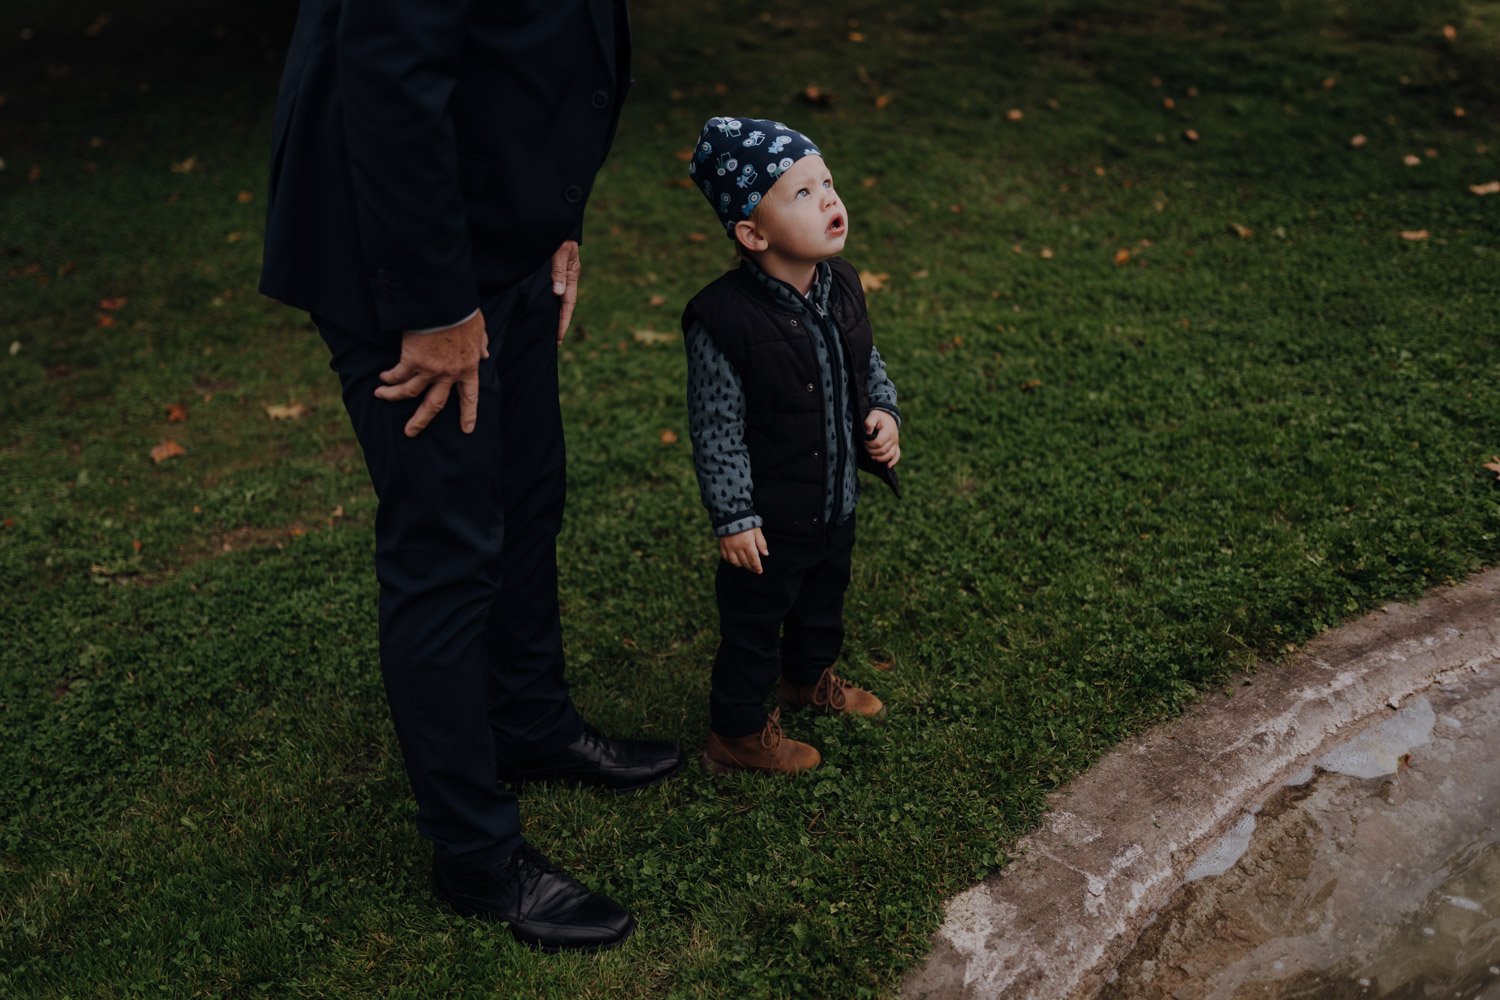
[708,517,854,738]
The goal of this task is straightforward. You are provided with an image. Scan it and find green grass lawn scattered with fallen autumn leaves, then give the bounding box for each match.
[0,0,1500,1000]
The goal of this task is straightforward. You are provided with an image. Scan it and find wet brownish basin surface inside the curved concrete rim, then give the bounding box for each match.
[1100,677,1500,1000]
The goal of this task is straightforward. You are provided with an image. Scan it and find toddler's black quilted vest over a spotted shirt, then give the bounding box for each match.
[683,256,900,535]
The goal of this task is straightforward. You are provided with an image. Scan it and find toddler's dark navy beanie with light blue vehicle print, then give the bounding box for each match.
[687,117,822,240]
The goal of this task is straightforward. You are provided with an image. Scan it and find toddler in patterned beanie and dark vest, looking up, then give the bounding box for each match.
[683,117,902,772]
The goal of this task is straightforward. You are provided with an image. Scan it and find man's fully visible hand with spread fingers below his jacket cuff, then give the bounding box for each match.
[375,312,489,438]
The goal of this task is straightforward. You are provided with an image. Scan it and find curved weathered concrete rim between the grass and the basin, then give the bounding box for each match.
[903,568,1500,1000]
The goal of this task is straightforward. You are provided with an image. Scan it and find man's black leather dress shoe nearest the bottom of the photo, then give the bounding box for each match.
[432,844,636,952]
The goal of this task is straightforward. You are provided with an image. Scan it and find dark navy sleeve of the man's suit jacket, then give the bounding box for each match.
[338,0,479,330]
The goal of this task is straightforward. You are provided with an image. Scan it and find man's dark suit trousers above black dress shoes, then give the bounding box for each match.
[315,267,582,871]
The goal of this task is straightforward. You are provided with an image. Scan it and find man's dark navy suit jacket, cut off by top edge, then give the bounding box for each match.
[261,0,630,342]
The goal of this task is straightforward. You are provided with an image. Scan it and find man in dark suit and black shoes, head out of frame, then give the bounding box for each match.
[261,0,683,951]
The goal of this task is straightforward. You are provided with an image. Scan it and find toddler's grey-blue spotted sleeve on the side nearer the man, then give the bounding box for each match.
[686,321,762,537]
